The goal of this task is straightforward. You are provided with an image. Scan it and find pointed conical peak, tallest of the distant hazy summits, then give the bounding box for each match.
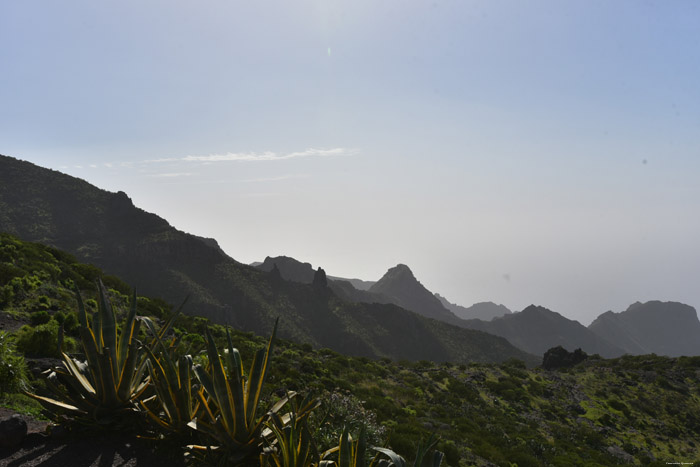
[369,264,463,326]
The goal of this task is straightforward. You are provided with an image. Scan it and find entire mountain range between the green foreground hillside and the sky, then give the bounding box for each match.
[0,156,700,363]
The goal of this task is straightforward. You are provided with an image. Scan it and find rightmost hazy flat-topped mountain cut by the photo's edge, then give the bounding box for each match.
[588,301,700,357]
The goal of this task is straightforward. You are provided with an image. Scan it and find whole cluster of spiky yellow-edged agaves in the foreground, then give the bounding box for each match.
[28,281,442,466]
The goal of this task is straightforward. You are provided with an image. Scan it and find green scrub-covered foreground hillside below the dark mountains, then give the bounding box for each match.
[0,237,700,467]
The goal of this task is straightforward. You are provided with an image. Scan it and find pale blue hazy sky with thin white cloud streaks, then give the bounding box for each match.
[0,0,700,324]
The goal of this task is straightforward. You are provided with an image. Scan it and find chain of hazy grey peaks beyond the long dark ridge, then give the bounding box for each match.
[258,256,700,357]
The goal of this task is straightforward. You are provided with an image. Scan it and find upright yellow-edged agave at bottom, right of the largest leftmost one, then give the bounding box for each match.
[189,322,288,465]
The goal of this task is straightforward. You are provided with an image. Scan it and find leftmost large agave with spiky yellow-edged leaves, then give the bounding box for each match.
[29,281,176,426]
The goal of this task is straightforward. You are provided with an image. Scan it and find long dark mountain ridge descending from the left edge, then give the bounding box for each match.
[0,156,536,364]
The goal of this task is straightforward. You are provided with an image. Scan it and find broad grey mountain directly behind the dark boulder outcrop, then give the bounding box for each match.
[465,305,625,357]
